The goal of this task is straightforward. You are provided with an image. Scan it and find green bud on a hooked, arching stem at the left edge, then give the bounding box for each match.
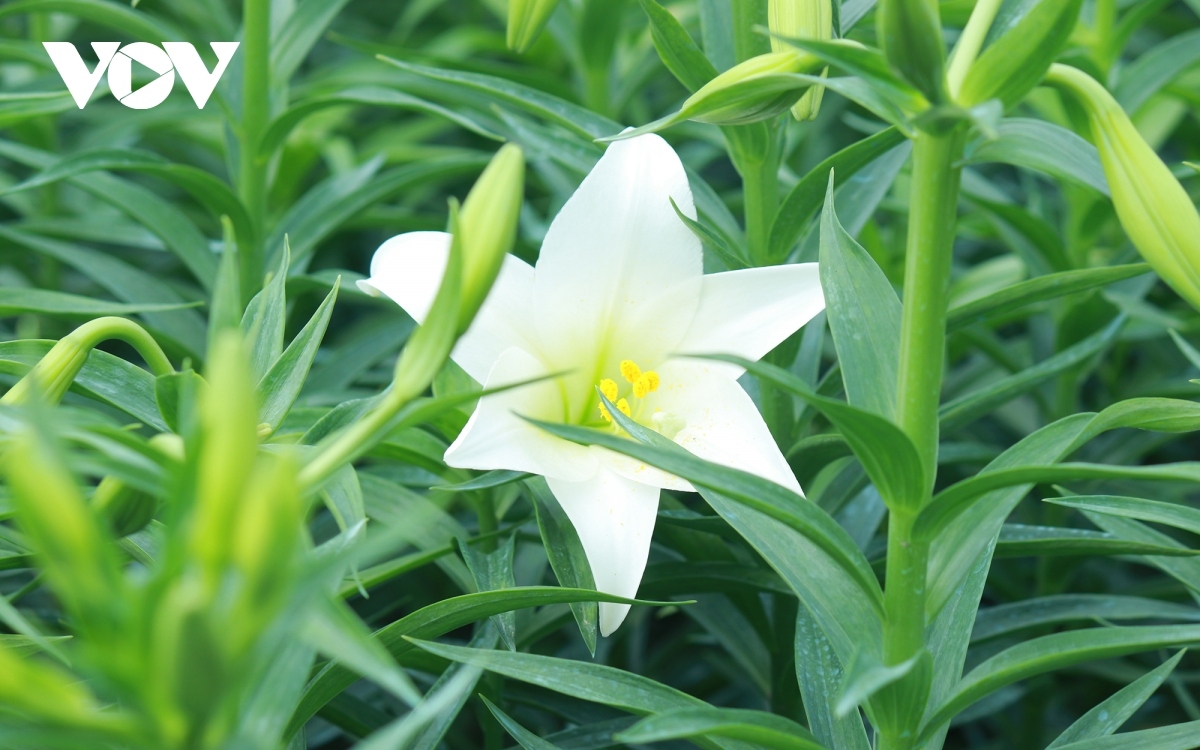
[0,318,175,404]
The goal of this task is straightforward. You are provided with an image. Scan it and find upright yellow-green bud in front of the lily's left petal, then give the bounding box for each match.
[454,143,524,334]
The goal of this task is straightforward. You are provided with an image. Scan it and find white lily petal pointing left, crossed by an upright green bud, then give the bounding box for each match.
[359,232,538,383]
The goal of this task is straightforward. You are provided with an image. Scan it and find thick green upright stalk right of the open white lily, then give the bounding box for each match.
[880,128,964,750]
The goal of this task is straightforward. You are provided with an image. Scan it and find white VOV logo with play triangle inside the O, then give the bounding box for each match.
[42,42,239,109]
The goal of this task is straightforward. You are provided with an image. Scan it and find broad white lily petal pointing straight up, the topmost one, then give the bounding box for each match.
[533,130,703,421]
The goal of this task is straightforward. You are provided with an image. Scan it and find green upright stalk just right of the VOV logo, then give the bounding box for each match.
[238,0,271,300]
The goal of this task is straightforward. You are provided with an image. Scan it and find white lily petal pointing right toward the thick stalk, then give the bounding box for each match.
[678,263,824,377]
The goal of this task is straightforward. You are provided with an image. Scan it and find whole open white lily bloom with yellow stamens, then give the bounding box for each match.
[359,136,824,635]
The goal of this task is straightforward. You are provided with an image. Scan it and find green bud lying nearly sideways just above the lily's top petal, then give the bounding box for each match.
[679,49,823,125]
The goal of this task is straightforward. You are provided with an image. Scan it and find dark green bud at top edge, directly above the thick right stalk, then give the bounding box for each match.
[875,0,946,103]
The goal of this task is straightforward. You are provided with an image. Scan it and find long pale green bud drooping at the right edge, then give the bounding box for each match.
[1046,64,1200,310]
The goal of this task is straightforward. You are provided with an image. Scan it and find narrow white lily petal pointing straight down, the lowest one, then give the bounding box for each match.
[547,469,659,636]
